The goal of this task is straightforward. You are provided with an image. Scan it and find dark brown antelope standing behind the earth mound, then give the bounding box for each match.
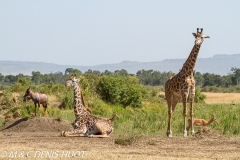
[23,87,48,116]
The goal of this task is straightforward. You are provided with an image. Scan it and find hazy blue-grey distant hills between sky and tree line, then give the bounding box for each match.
[0,54,240,75]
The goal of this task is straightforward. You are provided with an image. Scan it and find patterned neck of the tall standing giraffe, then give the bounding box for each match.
[181,44,201,75]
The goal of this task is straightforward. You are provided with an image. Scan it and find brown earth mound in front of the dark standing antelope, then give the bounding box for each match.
[0,117,72,132]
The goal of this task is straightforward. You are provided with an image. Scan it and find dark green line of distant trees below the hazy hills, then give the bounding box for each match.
[0,68,240,87]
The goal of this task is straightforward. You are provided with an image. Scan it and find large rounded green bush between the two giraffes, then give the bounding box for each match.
[97,75,146,107]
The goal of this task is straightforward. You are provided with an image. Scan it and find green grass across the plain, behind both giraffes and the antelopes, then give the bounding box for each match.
[0,87,240,137]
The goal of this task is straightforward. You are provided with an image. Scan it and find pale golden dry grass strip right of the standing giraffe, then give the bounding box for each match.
[202,92,240,104]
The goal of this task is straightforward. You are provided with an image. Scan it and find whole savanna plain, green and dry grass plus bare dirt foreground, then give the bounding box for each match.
[0,86,240,160]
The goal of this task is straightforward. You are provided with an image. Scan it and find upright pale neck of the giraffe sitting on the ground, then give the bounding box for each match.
[74,85,87,117]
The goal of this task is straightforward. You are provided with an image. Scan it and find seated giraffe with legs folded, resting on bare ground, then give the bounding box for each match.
[61,76,113,137]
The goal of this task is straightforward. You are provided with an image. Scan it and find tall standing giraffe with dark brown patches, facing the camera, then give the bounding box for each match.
[165,28,210,137]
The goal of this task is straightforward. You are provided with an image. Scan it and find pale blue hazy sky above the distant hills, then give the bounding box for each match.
[0,0,240,66]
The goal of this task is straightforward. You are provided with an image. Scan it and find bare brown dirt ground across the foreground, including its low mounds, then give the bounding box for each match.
[0,118,240,160]
